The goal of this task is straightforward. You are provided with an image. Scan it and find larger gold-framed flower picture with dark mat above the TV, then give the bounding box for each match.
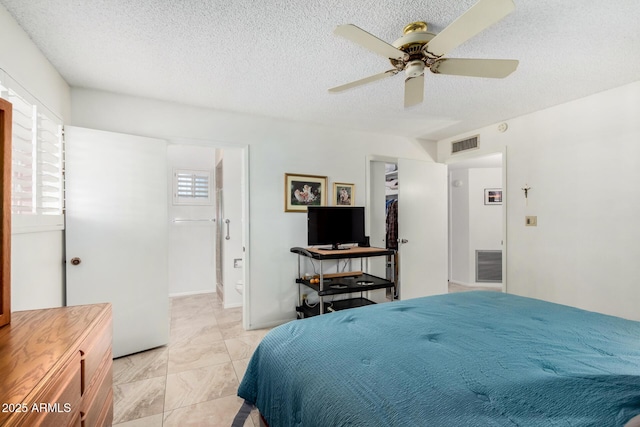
[284,173,327,212]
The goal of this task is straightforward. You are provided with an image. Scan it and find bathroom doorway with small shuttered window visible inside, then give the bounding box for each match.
[168,143,247,308]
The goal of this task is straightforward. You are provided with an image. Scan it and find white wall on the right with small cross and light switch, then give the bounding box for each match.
[438,82,640,320]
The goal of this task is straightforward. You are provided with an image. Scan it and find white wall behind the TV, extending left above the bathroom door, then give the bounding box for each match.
[67,89,430,328]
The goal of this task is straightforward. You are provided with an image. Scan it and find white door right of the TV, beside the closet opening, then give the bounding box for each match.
[398,159,448,300]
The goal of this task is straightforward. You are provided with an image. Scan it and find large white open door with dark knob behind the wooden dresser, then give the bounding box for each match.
[65,127,169,357]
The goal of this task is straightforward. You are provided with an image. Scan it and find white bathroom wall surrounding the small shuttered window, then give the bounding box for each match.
[167,144,216,296]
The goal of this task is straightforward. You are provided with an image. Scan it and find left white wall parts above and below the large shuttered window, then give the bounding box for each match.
[0,5,71,311]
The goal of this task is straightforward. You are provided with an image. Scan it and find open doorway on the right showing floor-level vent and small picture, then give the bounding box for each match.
[448,152,506,291]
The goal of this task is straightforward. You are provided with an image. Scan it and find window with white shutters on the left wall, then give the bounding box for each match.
[0,70,64,233]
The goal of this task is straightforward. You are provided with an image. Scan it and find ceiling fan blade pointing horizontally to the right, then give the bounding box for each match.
[430,58,518,79]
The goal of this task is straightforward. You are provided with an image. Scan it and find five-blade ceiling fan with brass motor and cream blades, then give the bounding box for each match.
[329,0,518,108]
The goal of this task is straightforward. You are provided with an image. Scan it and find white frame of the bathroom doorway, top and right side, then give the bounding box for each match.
[167,138,251,330]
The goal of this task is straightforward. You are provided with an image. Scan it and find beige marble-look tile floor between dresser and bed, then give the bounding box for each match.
[113,293,268,427]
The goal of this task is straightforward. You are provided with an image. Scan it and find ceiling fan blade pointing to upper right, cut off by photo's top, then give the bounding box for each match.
[424,0,515,57]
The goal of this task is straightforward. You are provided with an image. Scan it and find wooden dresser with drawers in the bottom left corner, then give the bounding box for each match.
[0,304,113,427]
